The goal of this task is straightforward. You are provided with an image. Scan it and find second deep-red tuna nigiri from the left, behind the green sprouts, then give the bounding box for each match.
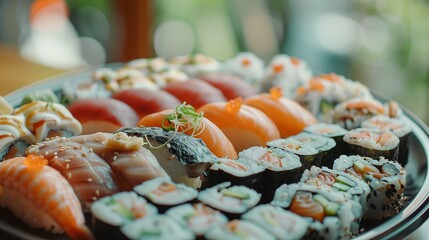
[113,89,180,118]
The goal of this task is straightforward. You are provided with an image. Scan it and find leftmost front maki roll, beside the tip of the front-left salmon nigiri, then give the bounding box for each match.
[91,192,158,239]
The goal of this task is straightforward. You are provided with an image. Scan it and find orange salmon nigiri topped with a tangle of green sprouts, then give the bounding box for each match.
[137,104,237,159]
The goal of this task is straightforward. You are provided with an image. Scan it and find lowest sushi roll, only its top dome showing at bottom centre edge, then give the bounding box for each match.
[204,219,276,240]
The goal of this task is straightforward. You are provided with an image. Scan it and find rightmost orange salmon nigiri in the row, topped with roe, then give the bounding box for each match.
[244,88,317,138]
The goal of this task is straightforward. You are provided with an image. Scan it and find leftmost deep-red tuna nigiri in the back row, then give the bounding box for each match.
[68,98,138,134]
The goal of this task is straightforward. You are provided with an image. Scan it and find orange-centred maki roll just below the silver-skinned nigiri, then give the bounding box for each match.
[134,177,198,213]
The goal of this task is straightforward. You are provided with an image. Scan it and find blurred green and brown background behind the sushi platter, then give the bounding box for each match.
[0,0,429,123]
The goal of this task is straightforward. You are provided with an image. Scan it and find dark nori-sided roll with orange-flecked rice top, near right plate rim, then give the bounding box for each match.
[343,128,399,161]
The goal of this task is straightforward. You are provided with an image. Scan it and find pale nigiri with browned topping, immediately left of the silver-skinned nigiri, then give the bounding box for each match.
[70,132,169,190]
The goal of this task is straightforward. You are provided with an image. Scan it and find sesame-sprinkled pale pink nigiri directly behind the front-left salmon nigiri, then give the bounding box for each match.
[26,137,118,211]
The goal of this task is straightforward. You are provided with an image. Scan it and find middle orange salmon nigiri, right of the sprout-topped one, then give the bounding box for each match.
[198,98,280,152]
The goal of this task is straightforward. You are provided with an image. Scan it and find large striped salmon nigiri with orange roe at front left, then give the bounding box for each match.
[0,155,92,239]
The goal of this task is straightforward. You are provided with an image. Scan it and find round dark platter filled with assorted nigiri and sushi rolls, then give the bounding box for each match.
[0,53,429,240]
